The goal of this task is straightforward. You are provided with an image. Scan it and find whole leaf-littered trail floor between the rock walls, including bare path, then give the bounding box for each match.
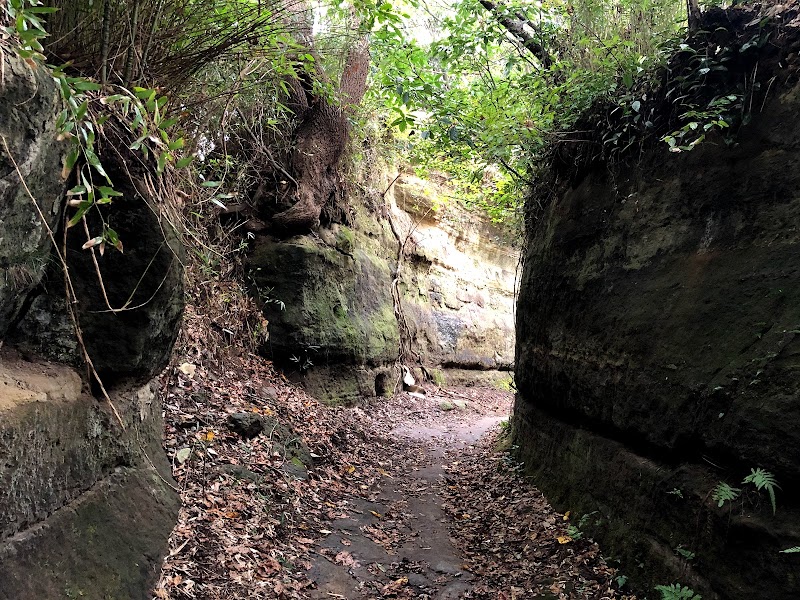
[154,355,632,600]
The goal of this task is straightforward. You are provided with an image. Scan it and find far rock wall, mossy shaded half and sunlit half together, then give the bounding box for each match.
[249,176,518,402]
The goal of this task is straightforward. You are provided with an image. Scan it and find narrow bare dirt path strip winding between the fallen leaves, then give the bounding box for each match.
[309,392,510,600]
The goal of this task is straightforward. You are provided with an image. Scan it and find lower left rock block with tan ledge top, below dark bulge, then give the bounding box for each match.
[0,351,180,600]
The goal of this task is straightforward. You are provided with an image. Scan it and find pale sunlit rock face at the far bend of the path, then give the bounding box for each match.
[391,177,519,377]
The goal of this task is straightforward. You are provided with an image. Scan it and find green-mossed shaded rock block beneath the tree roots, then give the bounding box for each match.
[249,237,399,367]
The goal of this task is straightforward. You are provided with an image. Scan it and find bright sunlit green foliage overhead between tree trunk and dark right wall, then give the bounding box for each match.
[370,0,680,222]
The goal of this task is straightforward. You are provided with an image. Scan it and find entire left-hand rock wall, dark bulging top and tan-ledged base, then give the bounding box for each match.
[0,52,183,600]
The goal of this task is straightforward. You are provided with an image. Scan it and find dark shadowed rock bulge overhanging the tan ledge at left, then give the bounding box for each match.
[7,164,183,385]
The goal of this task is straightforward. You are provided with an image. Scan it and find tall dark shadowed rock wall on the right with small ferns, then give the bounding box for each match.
[514,75,800,600]
